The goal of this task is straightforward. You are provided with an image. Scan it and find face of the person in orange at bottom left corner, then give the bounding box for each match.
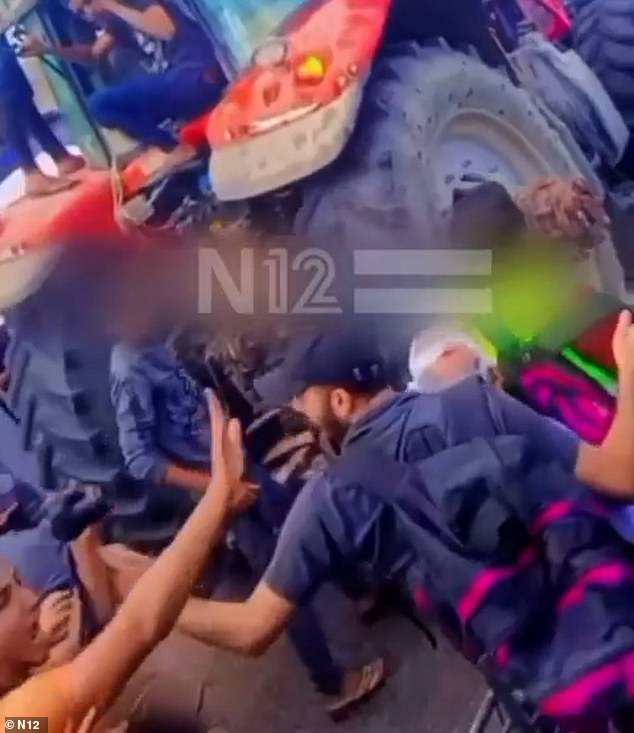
[0,563,49,682]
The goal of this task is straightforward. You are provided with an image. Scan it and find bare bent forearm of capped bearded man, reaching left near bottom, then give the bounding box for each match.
[178,582,295,656]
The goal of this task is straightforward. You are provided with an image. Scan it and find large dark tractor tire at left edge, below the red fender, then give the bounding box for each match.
[0,252,122,490]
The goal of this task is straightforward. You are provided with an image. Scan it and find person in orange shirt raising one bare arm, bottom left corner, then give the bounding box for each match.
[0,398,257,733]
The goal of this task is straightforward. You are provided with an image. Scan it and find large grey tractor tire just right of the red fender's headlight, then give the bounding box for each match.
[297,44,599,249]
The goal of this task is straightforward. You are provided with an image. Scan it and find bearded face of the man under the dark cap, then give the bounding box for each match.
[292,386,359,447]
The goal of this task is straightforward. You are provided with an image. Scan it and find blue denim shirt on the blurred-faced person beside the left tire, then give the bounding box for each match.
[110,343,211,483]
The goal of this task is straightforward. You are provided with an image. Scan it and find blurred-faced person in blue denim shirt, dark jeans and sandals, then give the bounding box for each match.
[111,295,385,717]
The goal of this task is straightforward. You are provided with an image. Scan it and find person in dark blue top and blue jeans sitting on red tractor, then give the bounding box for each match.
[24,0,226,159]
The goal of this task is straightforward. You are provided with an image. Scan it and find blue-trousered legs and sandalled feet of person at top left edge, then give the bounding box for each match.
[0,35,84,196]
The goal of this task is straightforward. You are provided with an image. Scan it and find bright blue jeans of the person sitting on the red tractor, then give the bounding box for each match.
[90,65,225,150]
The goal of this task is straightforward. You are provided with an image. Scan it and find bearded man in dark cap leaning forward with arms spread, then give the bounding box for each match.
[173,313,634,676]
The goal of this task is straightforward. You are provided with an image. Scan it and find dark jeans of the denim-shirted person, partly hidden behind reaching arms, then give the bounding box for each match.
[233,506,343,695]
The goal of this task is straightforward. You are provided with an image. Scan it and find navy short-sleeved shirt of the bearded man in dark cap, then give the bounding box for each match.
[264,378,579,605]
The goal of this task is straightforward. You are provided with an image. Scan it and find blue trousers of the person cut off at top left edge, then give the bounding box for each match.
[2,94,67,172]
